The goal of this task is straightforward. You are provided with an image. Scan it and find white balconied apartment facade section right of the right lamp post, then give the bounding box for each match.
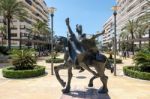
[117,0,148,38]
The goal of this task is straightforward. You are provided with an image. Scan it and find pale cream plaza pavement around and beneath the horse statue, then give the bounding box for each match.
[0,53,150,99]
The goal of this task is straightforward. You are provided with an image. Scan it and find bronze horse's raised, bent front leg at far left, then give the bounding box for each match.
[54,64,68,87]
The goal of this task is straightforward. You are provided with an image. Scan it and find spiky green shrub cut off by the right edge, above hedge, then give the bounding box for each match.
[133,49,150,72]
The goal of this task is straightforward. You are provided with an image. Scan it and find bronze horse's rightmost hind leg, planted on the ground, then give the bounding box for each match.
[94,62,108,93]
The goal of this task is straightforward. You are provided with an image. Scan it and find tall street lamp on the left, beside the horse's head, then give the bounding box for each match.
[48,7,56,75]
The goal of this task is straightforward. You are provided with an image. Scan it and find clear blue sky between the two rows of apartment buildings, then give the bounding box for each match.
[45,0,115,36]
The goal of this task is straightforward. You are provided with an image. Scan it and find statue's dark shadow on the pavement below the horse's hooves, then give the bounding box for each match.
[60,88,111,99]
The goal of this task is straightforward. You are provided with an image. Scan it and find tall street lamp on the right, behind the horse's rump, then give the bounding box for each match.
[112,6,119,76]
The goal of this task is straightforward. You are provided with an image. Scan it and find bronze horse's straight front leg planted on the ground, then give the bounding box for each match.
[62,66,73,93]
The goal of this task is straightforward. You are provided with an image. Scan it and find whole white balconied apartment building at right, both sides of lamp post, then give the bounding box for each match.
[103,0,149,45]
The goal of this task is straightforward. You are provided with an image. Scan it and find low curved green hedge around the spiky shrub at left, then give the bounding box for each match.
[2,66,45,78]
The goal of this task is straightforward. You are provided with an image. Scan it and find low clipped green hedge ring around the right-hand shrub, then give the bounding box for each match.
[123,66,150,80]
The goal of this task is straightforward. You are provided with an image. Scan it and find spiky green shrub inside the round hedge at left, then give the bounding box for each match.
[11,49,36,70]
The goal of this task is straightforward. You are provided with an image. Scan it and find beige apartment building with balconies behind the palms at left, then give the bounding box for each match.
[0,0,48,47]
